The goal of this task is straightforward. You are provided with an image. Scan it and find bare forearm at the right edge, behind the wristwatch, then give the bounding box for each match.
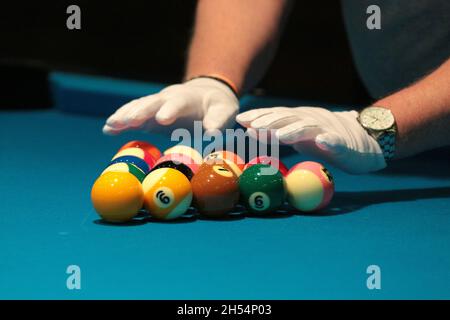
[376,59,450,158]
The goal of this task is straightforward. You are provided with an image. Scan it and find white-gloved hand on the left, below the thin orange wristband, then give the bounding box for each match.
[103,78,239,134]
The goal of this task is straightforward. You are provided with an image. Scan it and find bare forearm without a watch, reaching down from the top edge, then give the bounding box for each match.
[185,0,289,91]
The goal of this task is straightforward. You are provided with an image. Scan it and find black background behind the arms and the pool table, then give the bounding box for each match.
[0,0,369,106]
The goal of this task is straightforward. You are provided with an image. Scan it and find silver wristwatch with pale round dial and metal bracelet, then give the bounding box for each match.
[358,106,397,160]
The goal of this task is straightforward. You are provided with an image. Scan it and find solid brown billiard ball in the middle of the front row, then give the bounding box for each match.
[191,163,239,218]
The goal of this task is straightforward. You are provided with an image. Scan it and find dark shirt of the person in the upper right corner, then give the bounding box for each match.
[341,0,450,99]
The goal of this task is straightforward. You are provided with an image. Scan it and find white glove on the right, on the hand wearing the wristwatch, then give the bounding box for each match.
[236,107,386,174]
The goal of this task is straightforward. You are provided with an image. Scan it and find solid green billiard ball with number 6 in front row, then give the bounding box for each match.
[239,163,286,214]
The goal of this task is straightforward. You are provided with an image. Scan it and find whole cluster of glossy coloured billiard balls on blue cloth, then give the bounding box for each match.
[91,141,334,223]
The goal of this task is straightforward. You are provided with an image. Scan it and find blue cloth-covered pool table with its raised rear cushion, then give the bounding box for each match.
[0,74,450,299]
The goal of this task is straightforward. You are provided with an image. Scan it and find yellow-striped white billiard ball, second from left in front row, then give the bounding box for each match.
[142,168,192,220]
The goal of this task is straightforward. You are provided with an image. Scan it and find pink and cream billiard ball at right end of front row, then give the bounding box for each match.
[286,161,334,212]
